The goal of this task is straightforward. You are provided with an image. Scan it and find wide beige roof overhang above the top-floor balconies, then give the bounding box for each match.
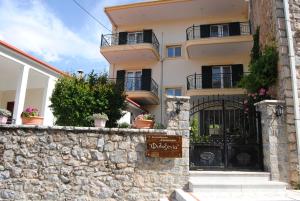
[104,0,249,27]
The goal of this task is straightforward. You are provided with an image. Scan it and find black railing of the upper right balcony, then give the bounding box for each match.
[186,22,251,40]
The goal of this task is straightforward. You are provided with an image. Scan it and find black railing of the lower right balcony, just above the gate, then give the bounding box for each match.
[186,73,247,90]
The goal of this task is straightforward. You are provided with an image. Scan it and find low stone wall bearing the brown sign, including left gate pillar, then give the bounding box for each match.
[0,97,189,201]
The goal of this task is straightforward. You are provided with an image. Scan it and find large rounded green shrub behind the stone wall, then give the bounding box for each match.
[50,72,126,127]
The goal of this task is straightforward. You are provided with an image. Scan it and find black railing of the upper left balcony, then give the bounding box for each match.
[101,32,159,52]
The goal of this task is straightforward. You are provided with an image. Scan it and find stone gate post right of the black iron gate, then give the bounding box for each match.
[255,100,289,182]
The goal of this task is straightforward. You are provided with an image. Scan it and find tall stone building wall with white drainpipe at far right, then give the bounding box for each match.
[251,0,300,184]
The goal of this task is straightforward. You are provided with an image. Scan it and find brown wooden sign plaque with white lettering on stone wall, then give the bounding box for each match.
[146,135,182,158]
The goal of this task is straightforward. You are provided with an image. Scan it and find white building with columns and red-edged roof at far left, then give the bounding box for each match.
[0,40,66,126]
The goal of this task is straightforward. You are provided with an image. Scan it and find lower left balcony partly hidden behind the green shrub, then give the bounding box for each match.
[112,77,159,105]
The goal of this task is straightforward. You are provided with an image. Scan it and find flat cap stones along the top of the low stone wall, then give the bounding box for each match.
[0,124,169,134]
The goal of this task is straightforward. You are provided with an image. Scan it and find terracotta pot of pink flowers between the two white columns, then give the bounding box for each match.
[21,107,44,125]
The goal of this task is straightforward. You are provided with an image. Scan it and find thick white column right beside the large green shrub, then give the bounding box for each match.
[41,77,56,126]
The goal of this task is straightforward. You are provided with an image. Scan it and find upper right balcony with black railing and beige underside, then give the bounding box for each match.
[186,22,253,59]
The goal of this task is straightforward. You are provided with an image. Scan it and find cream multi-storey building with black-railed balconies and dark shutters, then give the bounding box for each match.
[100,0,252,123]
